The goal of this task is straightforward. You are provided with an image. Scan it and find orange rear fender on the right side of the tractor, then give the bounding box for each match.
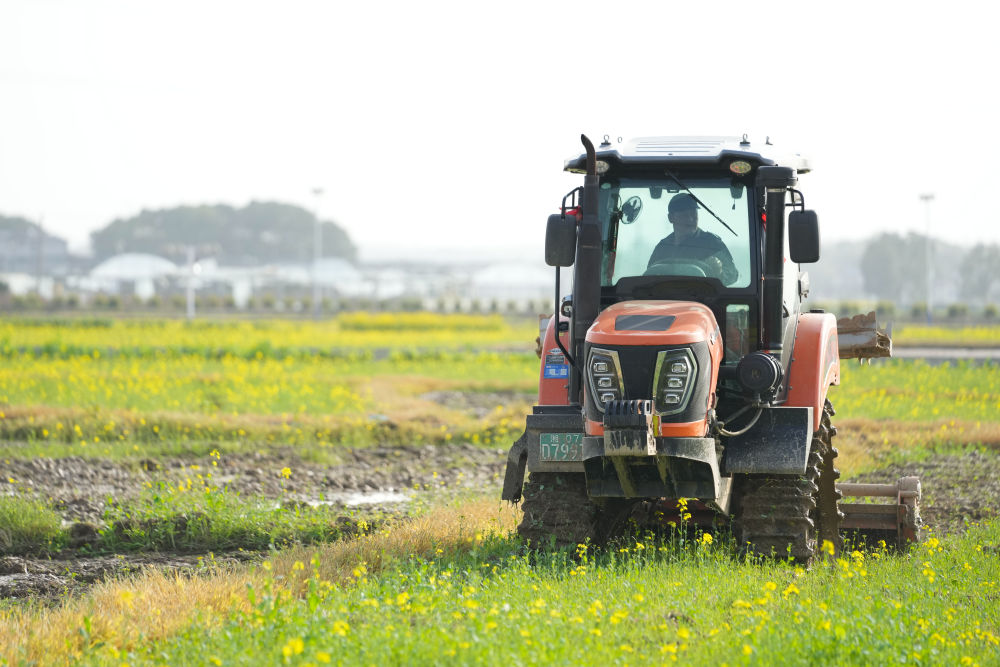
[785,313,840,432]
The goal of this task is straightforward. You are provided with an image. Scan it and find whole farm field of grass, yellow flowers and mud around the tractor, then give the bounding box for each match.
[0,314,1000,665]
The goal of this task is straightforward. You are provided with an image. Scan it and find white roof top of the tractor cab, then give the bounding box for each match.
[564,135,810,174]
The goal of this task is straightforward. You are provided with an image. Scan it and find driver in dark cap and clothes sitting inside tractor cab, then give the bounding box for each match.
[646,192,740,285]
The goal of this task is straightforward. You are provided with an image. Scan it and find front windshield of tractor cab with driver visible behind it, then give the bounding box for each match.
[599,174,751,288]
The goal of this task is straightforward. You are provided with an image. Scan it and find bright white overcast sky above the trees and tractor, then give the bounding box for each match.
[0,0,1000,260]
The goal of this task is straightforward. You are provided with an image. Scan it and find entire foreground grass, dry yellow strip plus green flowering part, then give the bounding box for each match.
[0,501,1000,665]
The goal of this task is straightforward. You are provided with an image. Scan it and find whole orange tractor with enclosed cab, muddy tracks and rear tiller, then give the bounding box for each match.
[503,136,920,562]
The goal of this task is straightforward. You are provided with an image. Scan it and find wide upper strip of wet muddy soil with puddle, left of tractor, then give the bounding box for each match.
[0,444,506,523]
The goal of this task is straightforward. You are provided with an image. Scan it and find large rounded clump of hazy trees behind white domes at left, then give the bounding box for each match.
[91,202,357,266]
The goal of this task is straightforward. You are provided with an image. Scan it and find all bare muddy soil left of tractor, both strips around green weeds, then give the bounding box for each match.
[0,444,506,599]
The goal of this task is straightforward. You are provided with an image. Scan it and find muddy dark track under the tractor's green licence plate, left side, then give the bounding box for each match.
[517,472,634,549]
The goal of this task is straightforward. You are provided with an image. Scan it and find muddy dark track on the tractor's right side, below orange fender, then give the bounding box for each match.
[733,401,843,564]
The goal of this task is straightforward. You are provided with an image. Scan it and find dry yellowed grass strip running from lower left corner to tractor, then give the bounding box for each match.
[0,499,514,664]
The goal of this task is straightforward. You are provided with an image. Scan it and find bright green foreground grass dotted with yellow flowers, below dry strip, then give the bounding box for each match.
[86,523,1000,665]
